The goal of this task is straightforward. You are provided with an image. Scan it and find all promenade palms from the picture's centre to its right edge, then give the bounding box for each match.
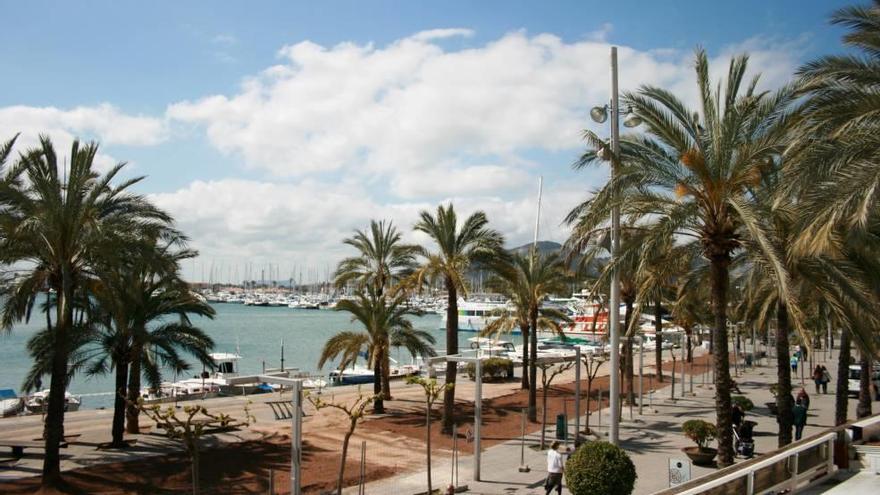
[322,0,880,472]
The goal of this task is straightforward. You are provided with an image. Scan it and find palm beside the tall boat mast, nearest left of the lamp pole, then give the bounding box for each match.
[483,251,570,422]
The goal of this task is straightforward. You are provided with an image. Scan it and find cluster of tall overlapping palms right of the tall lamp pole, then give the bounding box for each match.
[569,0,880,465]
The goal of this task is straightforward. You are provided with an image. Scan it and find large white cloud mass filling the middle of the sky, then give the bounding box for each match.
[158,30,799,280]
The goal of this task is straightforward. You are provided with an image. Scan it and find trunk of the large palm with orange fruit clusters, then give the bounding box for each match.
[710,253,734,467]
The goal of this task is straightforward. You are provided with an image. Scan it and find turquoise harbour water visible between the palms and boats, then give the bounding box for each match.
[0,304,520,409]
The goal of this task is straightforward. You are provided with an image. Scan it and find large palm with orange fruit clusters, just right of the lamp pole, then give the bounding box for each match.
[576,50,794,466]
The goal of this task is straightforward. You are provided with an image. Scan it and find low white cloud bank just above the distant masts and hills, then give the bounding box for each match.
[151,179,583,280]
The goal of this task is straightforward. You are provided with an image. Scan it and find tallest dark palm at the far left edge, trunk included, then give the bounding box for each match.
[0,137,171,488]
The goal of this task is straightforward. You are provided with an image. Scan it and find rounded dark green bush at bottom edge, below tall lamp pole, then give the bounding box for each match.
[565,442,637,495]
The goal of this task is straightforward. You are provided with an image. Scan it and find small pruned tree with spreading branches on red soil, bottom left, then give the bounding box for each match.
[137,400,256,495]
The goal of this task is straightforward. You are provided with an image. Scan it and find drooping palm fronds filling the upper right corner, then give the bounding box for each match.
[790,0,880,242]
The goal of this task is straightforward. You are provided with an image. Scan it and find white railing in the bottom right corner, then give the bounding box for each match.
[658,433,837,495]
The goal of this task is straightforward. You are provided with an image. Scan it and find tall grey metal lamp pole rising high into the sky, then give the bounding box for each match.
[608,46,620,445]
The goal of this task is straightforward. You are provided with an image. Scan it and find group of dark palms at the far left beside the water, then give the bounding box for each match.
[0,136,214,487]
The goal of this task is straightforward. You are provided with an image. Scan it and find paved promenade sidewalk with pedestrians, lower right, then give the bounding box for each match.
[356,344,868,495]
